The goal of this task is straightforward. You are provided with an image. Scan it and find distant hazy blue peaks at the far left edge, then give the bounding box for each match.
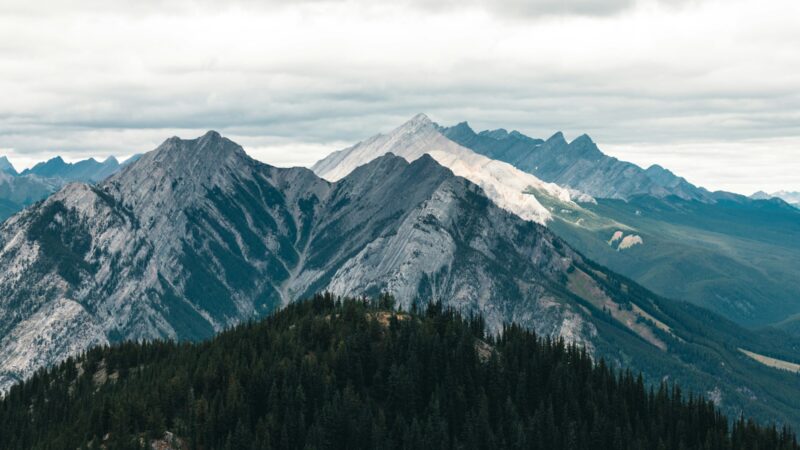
[0,155,140,222]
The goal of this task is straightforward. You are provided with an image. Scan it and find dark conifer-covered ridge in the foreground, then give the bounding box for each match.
[0,296,798,449]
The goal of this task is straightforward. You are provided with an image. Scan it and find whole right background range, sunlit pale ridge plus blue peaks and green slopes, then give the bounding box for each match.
[324,115,800,330]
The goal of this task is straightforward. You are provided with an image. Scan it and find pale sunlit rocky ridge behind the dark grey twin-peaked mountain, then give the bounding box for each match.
[311,114,592,224]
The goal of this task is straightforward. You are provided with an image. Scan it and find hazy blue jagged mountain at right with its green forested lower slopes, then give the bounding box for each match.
[442,123,800,329]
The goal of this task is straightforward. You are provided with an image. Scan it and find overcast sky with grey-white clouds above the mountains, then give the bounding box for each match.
[0,0,800,194]
